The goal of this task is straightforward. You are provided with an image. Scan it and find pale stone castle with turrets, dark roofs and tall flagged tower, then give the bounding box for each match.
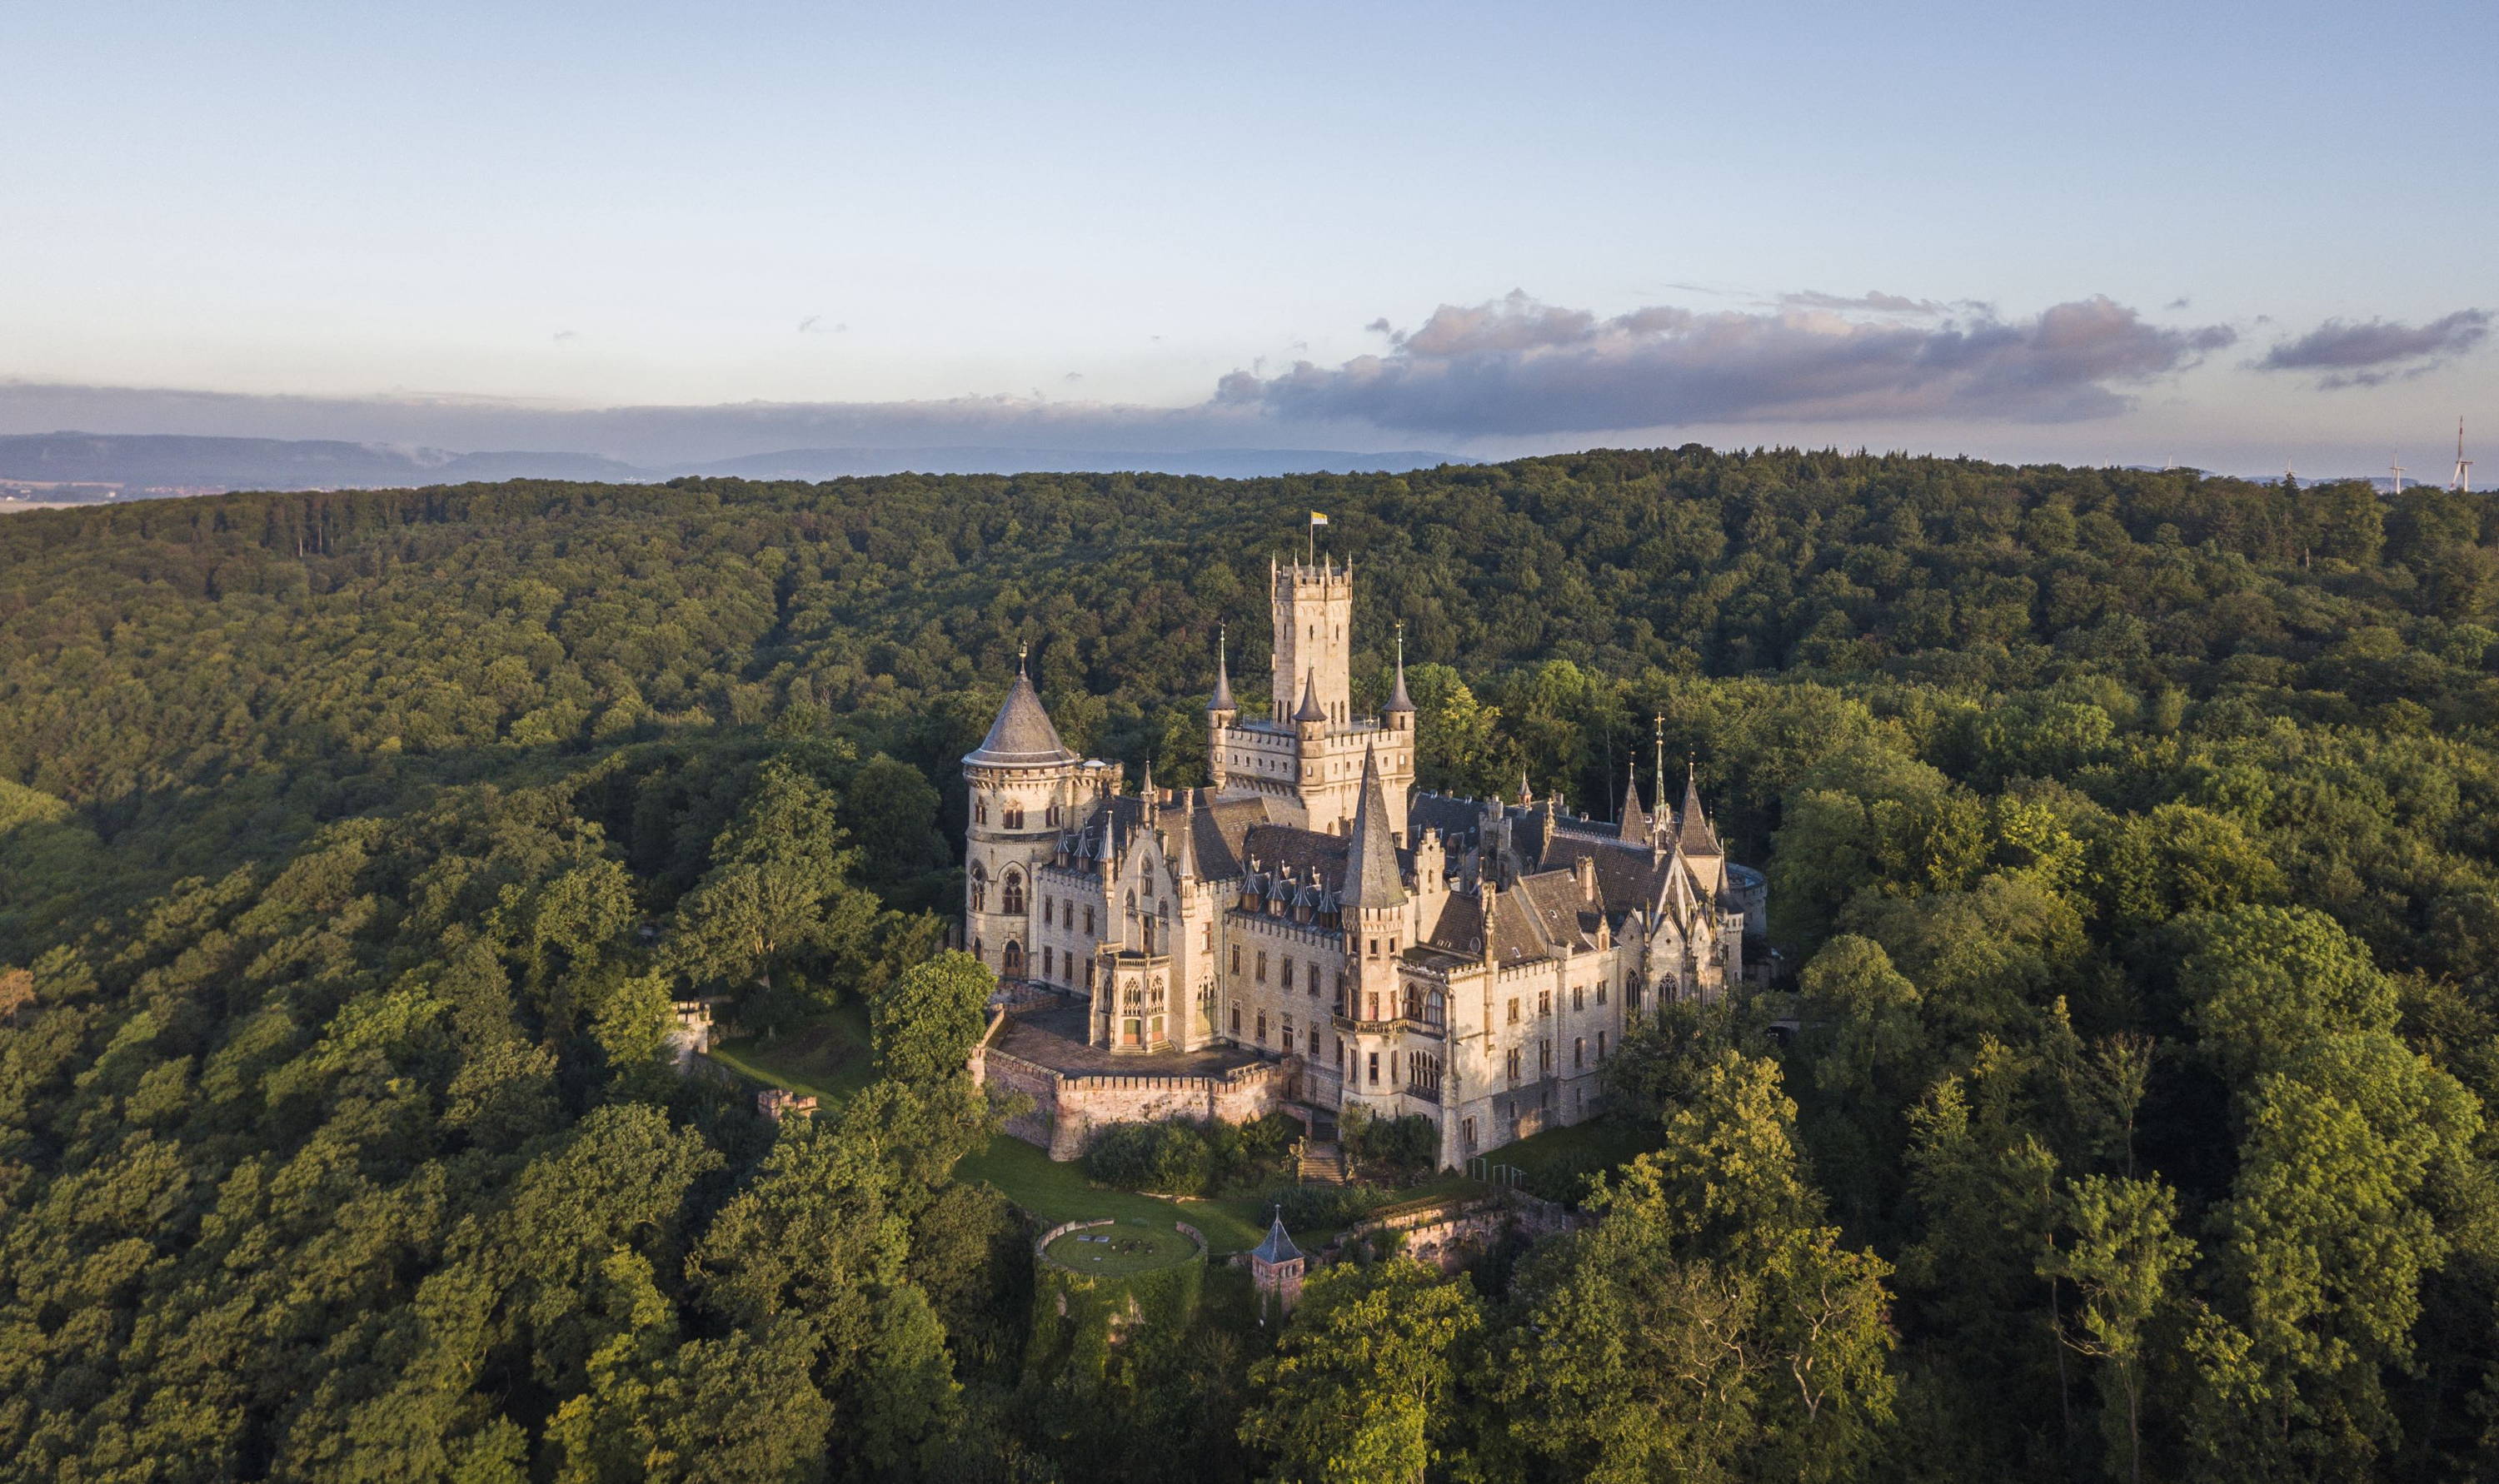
[962,550,1764,1167]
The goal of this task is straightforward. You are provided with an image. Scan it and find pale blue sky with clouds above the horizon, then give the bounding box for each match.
[0,0,2499,472]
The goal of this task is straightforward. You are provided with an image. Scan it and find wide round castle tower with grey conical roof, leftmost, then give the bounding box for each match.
[962,655,1097,979]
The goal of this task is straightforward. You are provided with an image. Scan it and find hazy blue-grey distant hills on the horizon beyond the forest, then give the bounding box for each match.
[0,432,1477,500]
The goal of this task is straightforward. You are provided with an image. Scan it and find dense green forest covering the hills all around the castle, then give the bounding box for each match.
[0,447,2499,1484]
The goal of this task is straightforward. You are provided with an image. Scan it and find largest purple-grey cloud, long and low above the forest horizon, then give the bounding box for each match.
[1217,292,2234,437]
